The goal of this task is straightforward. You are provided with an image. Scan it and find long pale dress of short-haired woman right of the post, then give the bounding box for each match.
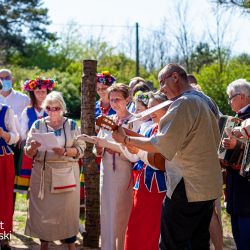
[98,115,133,250]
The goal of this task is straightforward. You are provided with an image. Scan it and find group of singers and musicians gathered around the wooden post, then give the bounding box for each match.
[0,63,250,250]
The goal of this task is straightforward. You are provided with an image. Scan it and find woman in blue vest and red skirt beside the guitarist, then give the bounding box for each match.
[114,92,167,250]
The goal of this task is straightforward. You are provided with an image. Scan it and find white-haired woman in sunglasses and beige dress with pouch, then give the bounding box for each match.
[25,91,86,250]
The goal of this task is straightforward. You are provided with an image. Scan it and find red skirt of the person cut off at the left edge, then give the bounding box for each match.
[0,154,15,234]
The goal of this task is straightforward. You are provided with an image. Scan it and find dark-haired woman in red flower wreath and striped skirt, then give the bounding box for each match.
[15,77,55,193]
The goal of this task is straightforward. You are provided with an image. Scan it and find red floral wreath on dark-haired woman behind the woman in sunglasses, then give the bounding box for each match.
[23,76,56,91]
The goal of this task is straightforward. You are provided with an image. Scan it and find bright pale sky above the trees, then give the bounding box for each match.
[44,0,250,54]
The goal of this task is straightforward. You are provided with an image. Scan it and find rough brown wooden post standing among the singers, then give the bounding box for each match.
[81,60,100,248]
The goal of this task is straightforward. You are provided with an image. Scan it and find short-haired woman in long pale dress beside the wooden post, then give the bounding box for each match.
[97,84,135,250]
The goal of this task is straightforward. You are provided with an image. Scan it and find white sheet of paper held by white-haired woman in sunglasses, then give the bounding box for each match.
[32,132,60,151]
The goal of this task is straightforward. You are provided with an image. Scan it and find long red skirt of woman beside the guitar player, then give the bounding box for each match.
[124,174,166,250]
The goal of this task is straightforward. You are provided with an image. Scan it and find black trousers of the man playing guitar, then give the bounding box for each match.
[159,179,214,250]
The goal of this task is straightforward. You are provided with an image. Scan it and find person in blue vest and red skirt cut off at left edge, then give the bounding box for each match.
[0,81,19,250]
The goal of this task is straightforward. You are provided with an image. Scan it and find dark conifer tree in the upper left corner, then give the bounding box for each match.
[0,0,55,63]
